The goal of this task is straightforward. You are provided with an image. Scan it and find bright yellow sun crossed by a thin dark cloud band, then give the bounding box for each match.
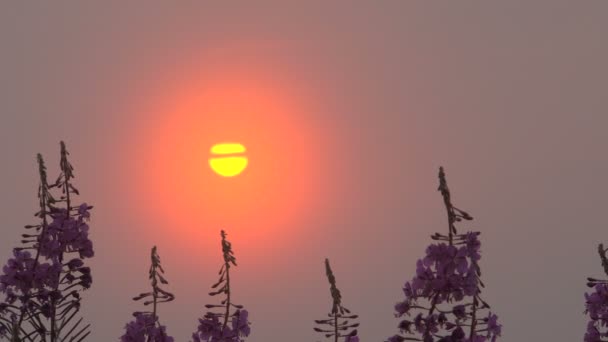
[209,143,249,177]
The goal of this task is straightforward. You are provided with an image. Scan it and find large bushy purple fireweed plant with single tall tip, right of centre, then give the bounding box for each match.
[388,167,502,342]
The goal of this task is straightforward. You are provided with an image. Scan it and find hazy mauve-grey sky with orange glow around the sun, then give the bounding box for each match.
[0,0,608,342]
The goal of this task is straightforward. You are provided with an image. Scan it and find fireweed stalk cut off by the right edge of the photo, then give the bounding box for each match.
[584,243,608,342]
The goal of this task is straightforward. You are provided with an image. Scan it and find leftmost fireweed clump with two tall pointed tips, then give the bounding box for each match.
[0,141,94,342]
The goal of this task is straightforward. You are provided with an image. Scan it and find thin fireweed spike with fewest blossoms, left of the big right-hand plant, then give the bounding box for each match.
[314,259,359,342]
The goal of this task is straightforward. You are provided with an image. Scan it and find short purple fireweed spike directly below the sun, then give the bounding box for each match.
[192,230,251,342]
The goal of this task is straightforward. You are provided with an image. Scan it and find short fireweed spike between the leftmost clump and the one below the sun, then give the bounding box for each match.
[120,246,175,342]
